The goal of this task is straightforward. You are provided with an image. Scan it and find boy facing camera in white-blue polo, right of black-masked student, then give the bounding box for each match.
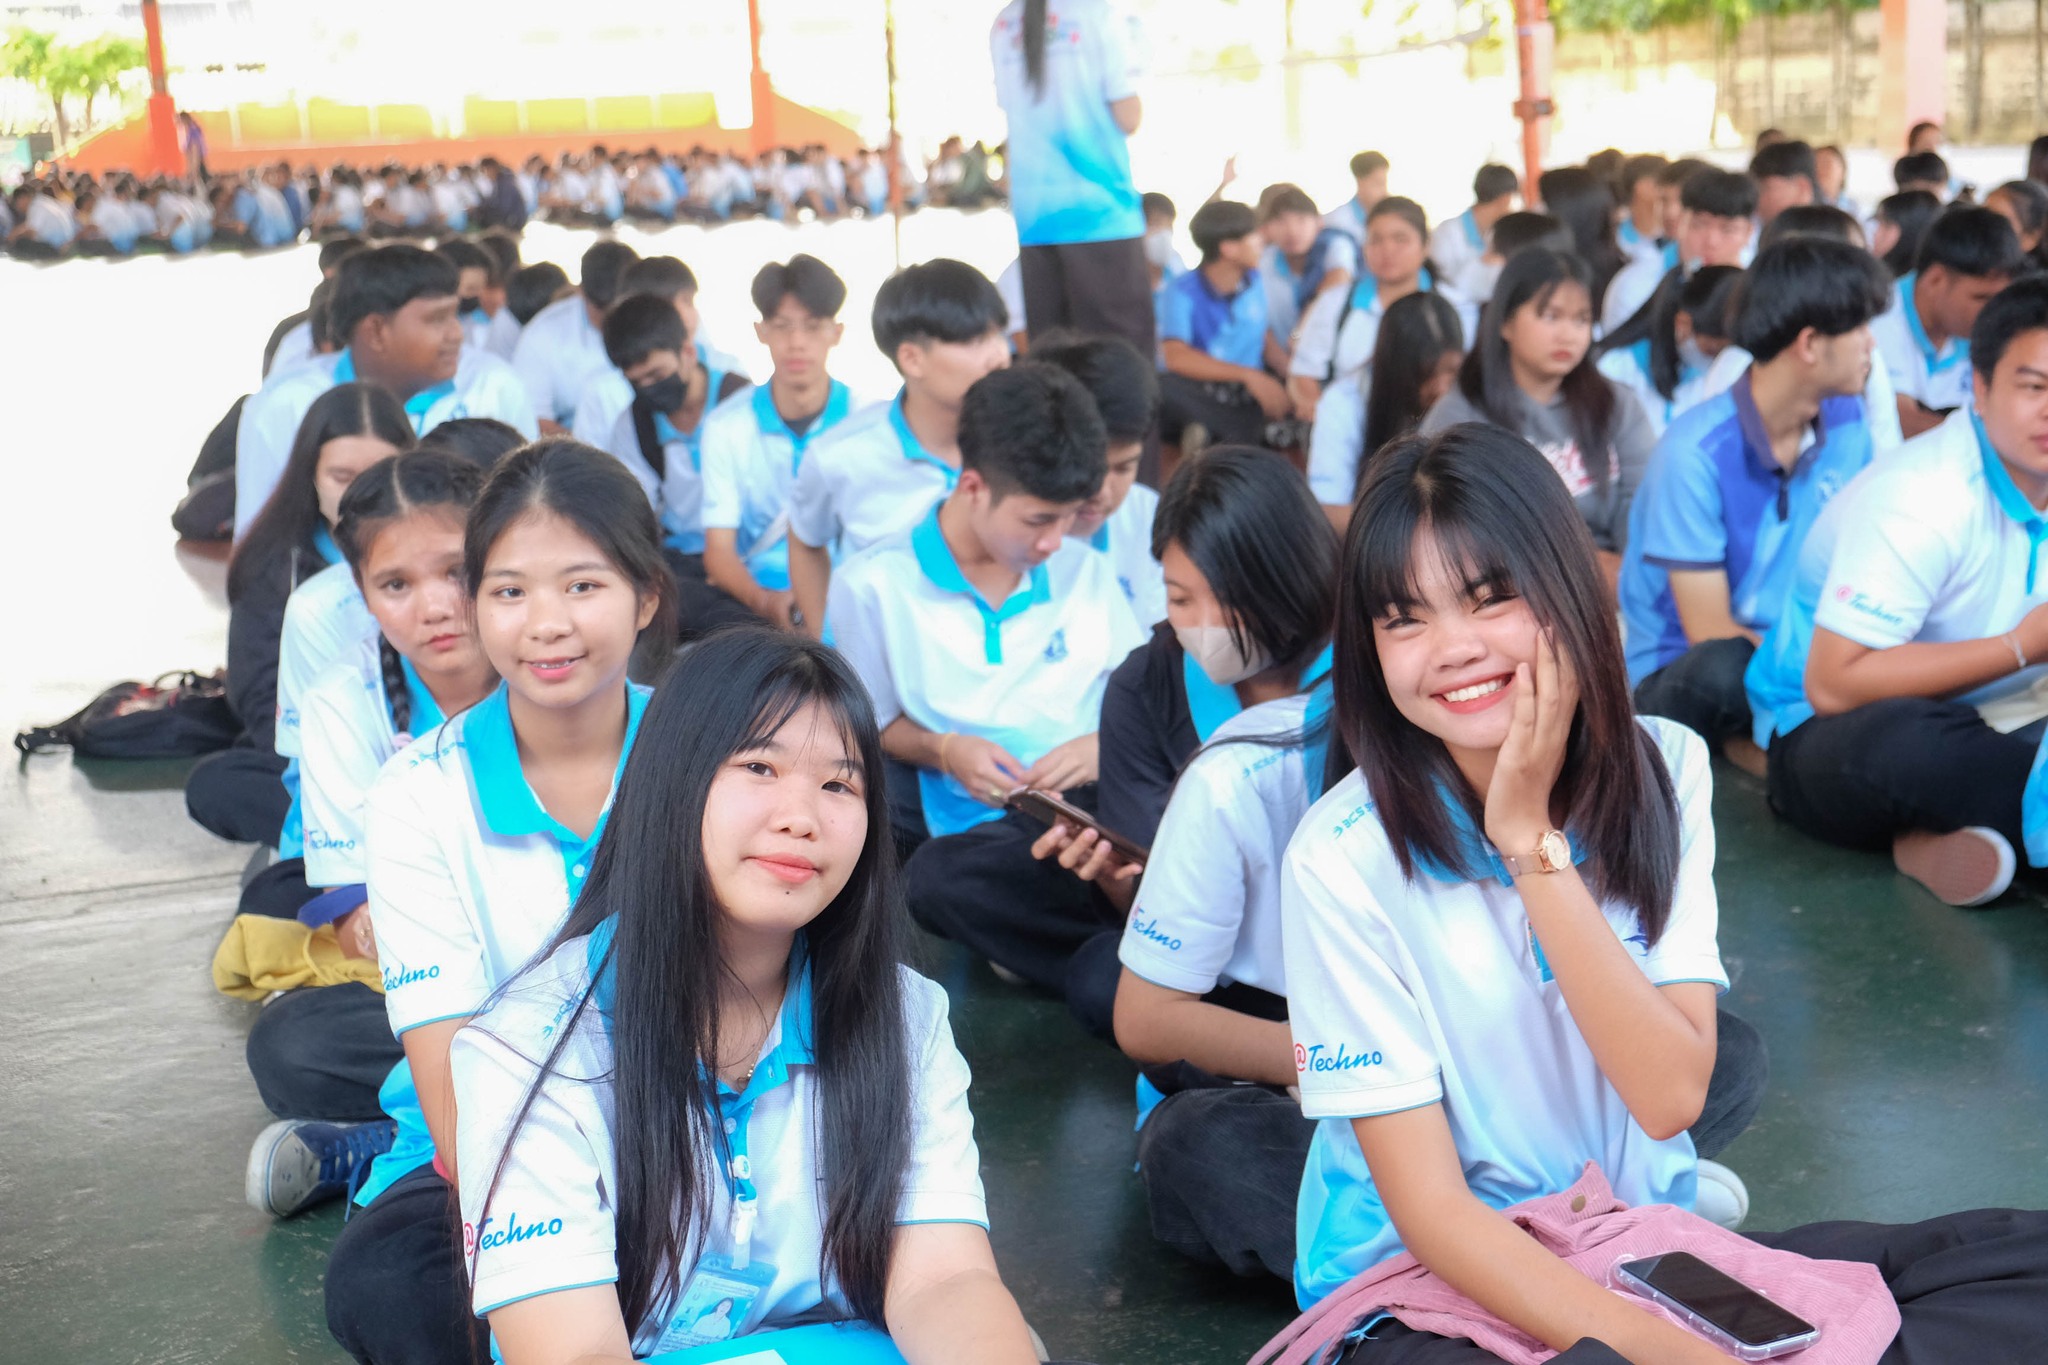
[700,256,854,626]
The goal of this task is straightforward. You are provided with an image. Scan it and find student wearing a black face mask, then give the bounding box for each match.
[604,295,754,639]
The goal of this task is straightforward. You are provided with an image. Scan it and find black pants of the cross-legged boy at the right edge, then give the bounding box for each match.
[1765,698,2042,851]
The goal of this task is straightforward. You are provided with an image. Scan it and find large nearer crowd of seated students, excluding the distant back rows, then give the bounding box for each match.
[163,96,2048,1365]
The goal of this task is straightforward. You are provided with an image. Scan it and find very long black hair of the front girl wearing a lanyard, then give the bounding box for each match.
[477,626,911,1334]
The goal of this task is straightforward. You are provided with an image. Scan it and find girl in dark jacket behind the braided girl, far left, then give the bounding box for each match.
[184,385,414,860]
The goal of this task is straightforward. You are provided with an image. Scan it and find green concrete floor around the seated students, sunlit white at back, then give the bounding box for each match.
[0,215,2048,1365]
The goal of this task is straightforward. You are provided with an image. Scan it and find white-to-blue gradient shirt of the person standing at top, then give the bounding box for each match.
[989,0,1145,246]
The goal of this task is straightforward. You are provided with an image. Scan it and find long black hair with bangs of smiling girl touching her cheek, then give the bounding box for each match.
[1331,422,1679,943]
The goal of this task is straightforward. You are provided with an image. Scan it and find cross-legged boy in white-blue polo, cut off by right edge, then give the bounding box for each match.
[1747,278,2048,905]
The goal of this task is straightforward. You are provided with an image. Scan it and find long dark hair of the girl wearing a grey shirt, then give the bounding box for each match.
[1458,246,1616,497]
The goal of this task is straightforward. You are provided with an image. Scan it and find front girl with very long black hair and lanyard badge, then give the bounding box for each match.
[453,626,1036,1365]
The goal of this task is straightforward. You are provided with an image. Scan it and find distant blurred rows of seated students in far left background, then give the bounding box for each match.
[0,137,1008,262]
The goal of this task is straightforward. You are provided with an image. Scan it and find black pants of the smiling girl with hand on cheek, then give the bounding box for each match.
[1339,1209,2048,1365]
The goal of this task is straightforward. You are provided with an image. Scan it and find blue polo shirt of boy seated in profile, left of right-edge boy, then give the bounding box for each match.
[1620,375,1872,684]
